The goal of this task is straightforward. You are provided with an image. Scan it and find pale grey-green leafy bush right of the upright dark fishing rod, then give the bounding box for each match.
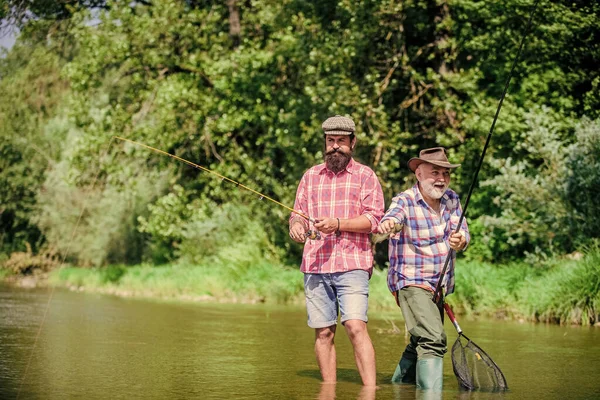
[480,107,573,262]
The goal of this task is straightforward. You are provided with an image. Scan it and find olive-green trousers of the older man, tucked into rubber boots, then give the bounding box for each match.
[396,286,447,360]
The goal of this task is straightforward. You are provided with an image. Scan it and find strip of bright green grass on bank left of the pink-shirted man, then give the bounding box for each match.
[51,262,304,303]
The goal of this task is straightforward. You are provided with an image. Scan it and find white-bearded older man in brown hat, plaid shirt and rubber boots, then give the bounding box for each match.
[378,147,470,391]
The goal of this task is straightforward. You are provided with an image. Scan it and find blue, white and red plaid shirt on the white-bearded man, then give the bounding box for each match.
[382,184,471,294]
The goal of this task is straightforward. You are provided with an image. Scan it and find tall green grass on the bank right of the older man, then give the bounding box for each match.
[448,247,600,325]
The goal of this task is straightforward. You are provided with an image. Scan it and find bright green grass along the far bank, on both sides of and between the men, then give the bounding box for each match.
[38,244,600,325]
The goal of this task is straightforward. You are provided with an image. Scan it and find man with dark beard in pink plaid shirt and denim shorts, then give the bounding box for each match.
[289,115,384,386]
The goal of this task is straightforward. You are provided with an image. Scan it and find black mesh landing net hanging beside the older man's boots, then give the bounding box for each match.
[452,333,508,392]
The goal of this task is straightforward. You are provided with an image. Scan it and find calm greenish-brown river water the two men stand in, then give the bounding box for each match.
[0,286,600,400]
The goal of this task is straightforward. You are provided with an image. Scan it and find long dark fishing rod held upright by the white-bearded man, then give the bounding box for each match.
[433,0,539,303]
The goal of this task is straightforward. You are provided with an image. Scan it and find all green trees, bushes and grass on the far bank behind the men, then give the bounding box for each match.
[0,0,600,324]
